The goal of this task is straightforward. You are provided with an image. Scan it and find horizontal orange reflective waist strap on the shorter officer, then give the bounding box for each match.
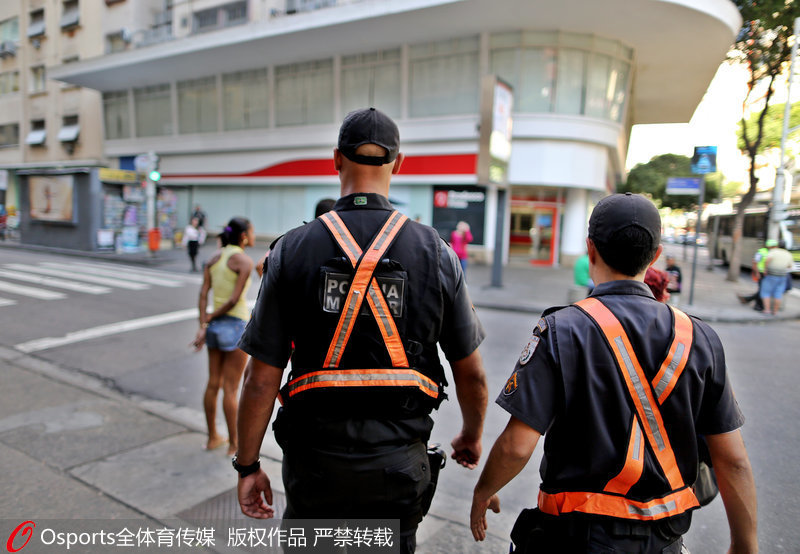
[539,487,700,521]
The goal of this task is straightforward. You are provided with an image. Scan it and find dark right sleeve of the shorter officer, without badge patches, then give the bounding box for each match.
[695,321,744,435]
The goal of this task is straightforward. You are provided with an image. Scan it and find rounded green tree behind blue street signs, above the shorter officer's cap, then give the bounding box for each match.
[617,154,722,210]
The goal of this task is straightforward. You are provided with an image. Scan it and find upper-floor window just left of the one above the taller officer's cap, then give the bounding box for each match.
[275,60,333,126]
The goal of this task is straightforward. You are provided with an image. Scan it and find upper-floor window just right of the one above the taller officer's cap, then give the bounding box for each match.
[409,37,480,117]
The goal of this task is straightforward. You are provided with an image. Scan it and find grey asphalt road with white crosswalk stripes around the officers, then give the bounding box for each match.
[0,250,800,553]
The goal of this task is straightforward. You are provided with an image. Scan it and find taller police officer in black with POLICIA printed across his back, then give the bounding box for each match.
[234,108,488,552]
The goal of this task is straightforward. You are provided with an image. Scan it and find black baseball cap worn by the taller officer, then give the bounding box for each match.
[338,108,400,165]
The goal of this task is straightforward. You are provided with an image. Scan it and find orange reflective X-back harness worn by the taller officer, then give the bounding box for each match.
[281,210,439,399]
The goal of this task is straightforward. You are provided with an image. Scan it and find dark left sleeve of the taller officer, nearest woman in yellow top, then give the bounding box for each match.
[239,234,292,368]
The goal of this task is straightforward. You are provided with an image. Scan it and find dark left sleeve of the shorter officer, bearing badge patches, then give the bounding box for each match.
[495,318,563,435]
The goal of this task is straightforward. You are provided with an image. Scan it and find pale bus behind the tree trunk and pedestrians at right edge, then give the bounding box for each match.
[706,206,800,274]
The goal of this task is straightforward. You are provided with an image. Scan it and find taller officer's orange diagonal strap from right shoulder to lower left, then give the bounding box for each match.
[324,211,408,367]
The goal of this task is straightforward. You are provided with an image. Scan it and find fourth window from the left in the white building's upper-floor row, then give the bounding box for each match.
[222,69,269,131]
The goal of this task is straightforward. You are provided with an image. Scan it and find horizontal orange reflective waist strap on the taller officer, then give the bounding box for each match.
[284,368,439,398]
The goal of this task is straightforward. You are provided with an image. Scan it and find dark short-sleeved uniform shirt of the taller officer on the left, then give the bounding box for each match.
[239,193,485,442]
